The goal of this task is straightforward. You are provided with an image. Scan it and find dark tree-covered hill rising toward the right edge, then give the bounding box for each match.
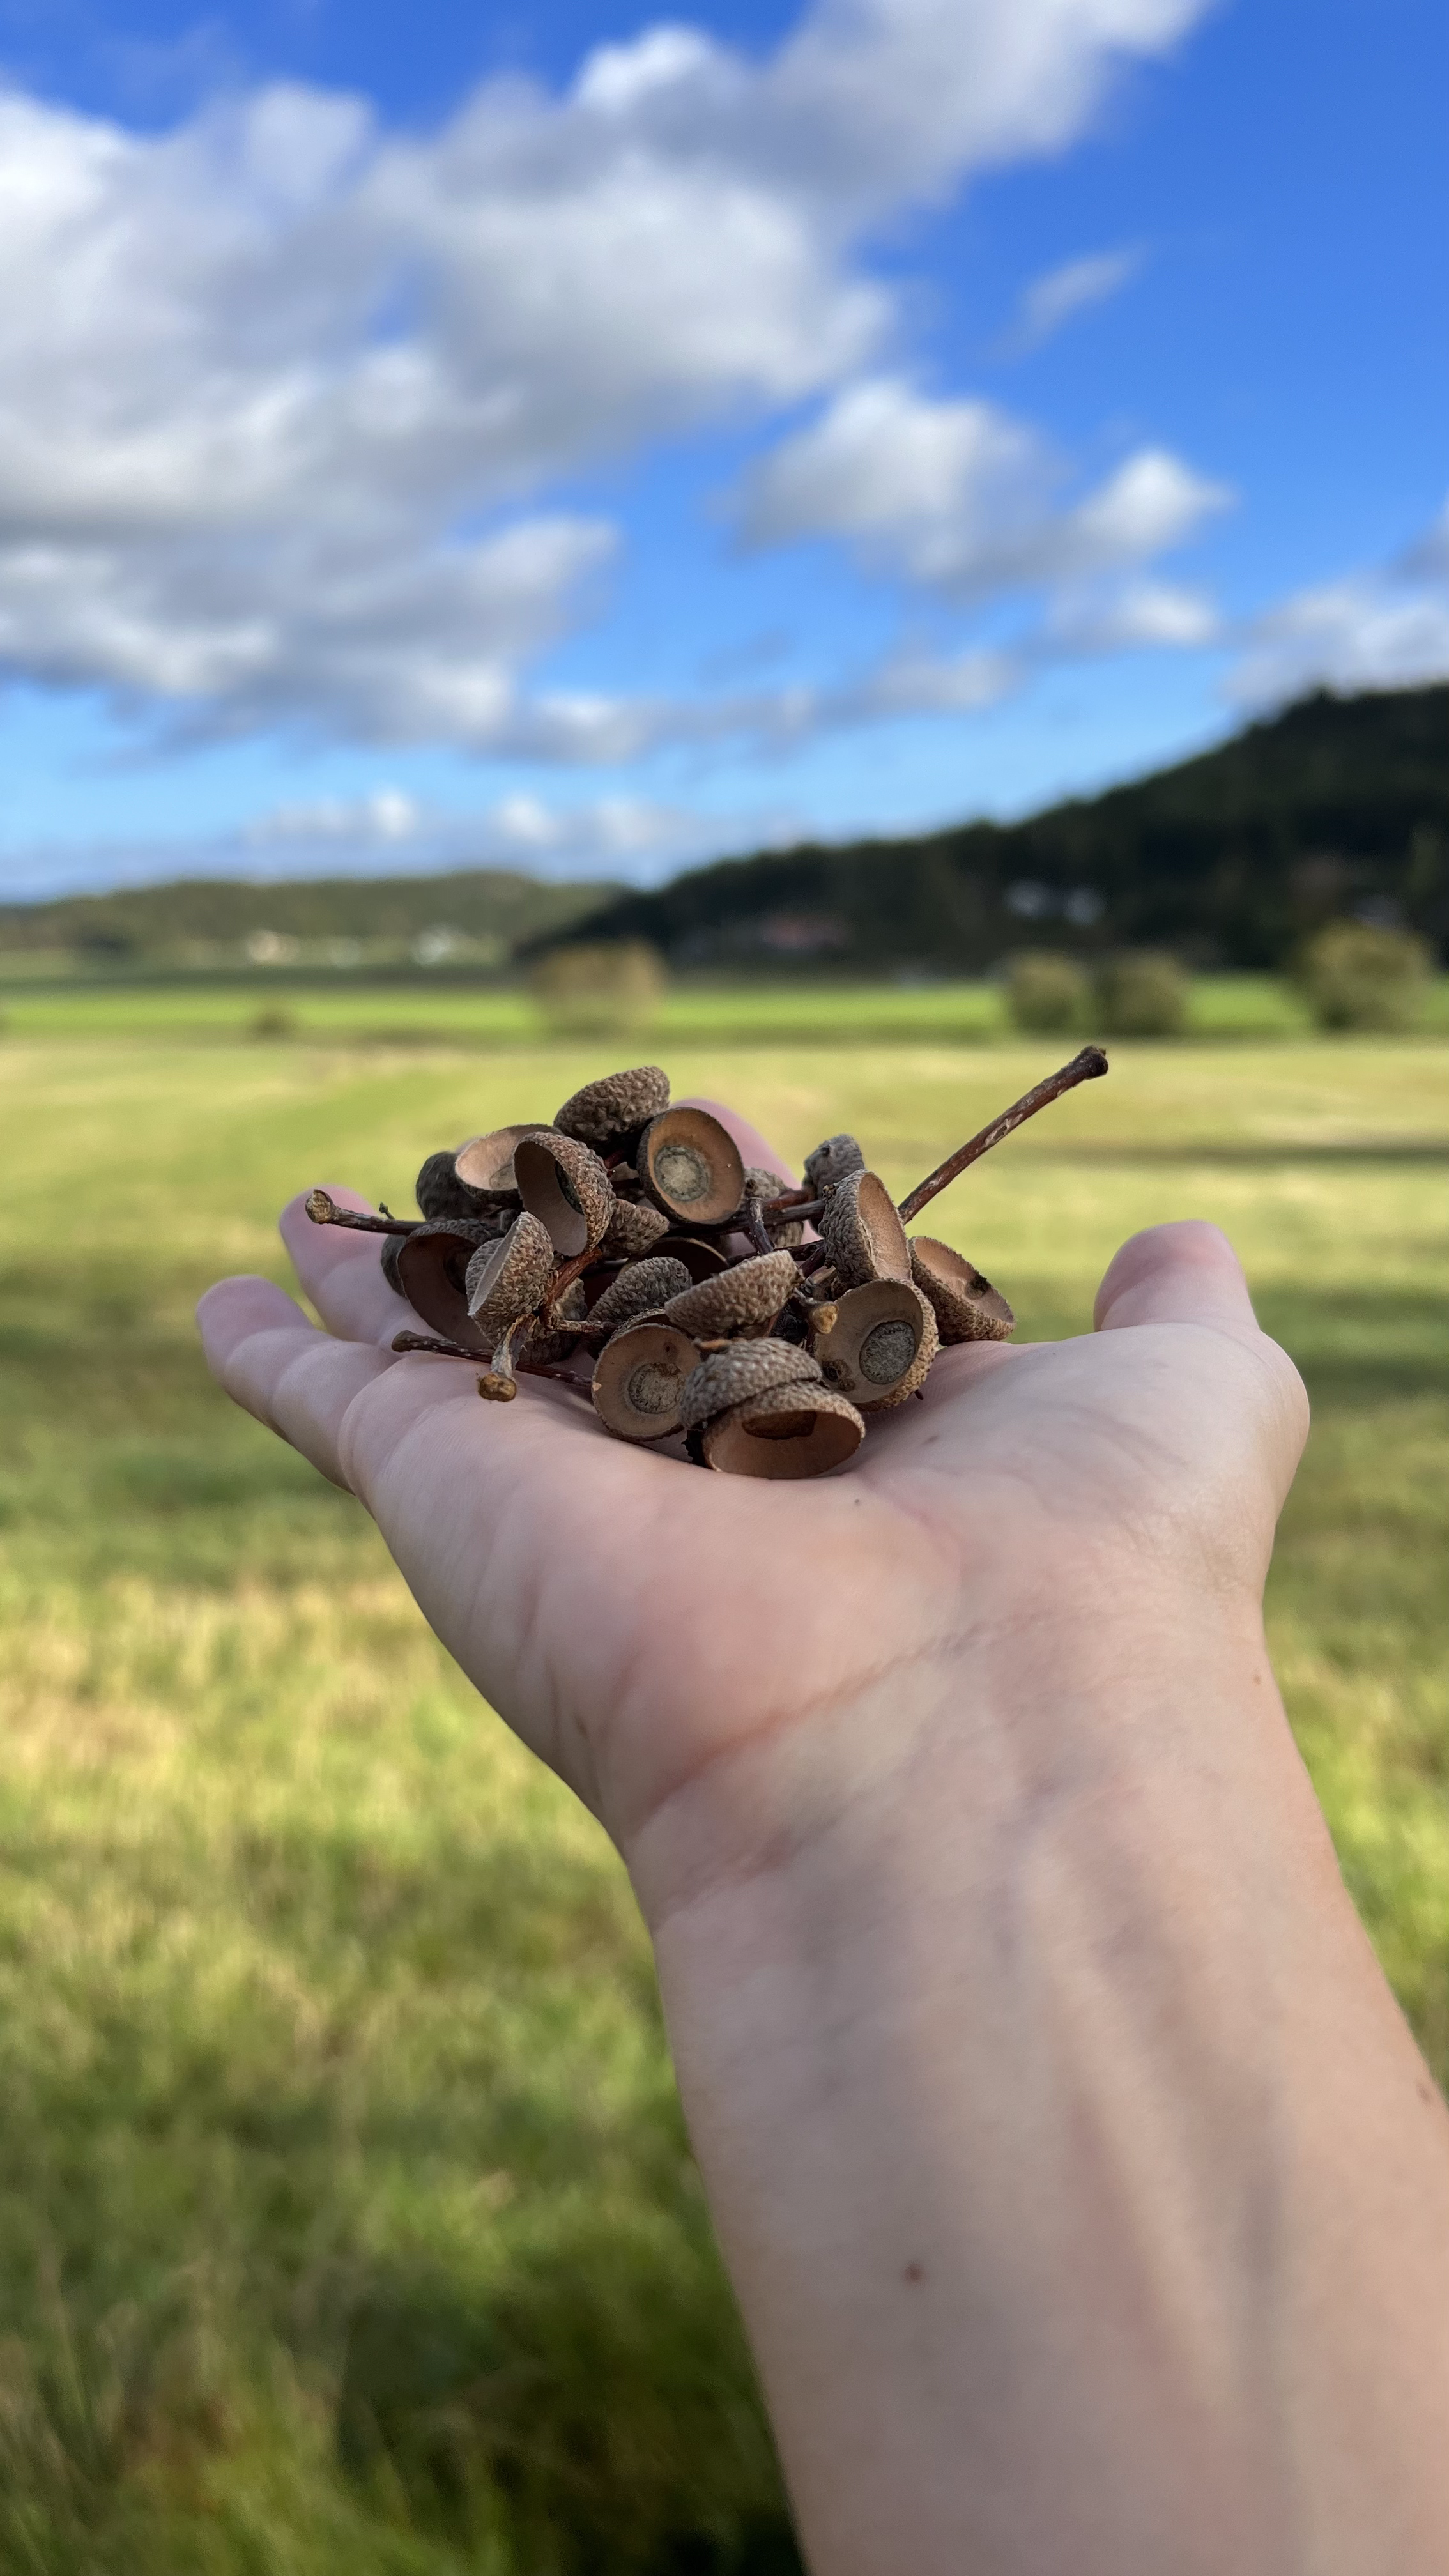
[551,686,1449,974]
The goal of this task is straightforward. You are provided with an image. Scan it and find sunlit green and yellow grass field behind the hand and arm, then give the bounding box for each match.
[0,997,1449,2576]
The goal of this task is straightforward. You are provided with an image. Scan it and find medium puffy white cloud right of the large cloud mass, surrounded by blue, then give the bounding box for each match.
[737,376,1230,597]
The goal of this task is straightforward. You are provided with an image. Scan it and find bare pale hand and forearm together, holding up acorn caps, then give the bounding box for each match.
[201,1118,1449,2576]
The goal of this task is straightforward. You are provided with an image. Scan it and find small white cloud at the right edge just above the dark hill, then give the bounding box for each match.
[1227,502,1449,706]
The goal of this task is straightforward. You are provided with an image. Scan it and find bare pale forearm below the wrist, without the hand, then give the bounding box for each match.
[634,1602,1449,2576]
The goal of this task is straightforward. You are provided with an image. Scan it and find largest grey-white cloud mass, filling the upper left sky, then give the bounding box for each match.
[0,0,1204,757]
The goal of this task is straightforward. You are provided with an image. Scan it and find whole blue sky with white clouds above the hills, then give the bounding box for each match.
[0,0,1449,894]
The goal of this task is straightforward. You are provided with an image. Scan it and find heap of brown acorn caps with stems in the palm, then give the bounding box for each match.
[307,1048,1106,1478]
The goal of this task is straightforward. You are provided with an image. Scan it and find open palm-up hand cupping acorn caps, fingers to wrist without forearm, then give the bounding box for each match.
[201,1113,1305,1901]
